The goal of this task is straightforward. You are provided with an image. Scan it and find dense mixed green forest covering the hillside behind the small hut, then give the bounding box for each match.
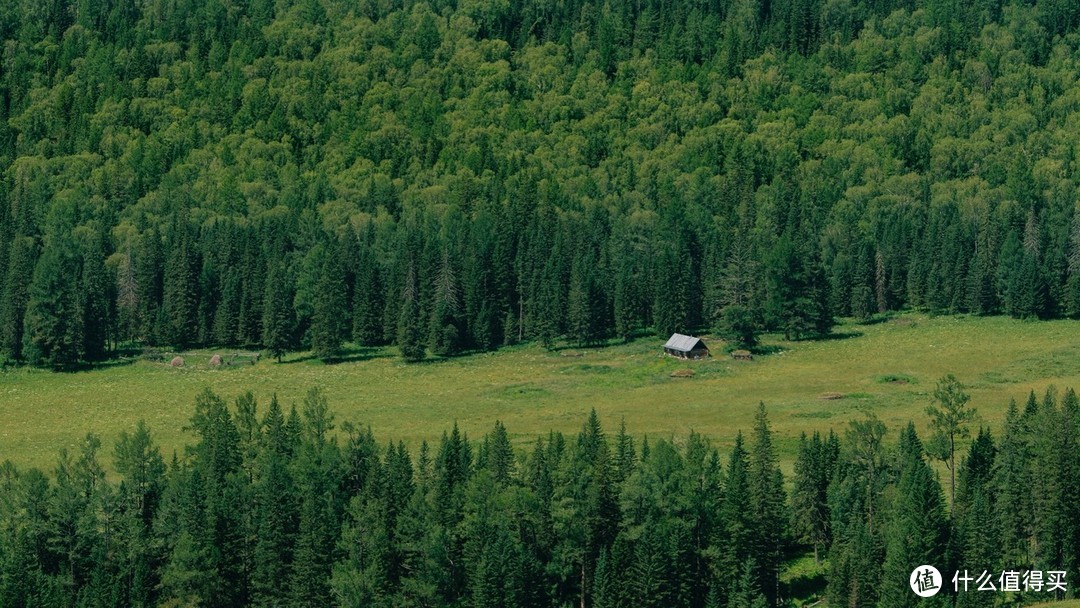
[0,0,1080,366]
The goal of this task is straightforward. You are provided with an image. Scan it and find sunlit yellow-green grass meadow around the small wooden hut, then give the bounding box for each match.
[0,315,1080,472]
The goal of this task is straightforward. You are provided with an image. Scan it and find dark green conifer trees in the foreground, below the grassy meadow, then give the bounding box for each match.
[0,378,1080,608]
